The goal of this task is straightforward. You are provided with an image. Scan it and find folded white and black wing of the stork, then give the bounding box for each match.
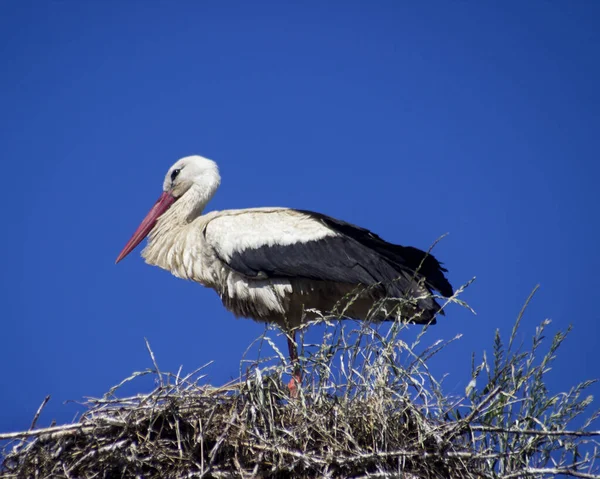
[204,208,452,322]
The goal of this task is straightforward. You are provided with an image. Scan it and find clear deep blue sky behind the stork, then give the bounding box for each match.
[0,1,600,431]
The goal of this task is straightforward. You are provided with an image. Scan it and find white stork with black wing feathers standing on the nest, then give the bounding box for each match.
[116,155,453,396]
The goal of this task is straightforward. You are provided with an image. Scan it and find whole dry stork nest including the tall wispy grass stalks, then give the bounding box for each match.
[0,284,600,479]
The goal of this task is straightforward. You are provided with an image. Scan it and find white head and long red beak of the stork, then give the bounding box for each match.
[116,155,221,263]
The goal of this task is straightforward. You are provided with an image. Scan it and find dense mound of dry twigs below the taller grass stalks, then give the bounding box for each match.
[4,375,482,478]
